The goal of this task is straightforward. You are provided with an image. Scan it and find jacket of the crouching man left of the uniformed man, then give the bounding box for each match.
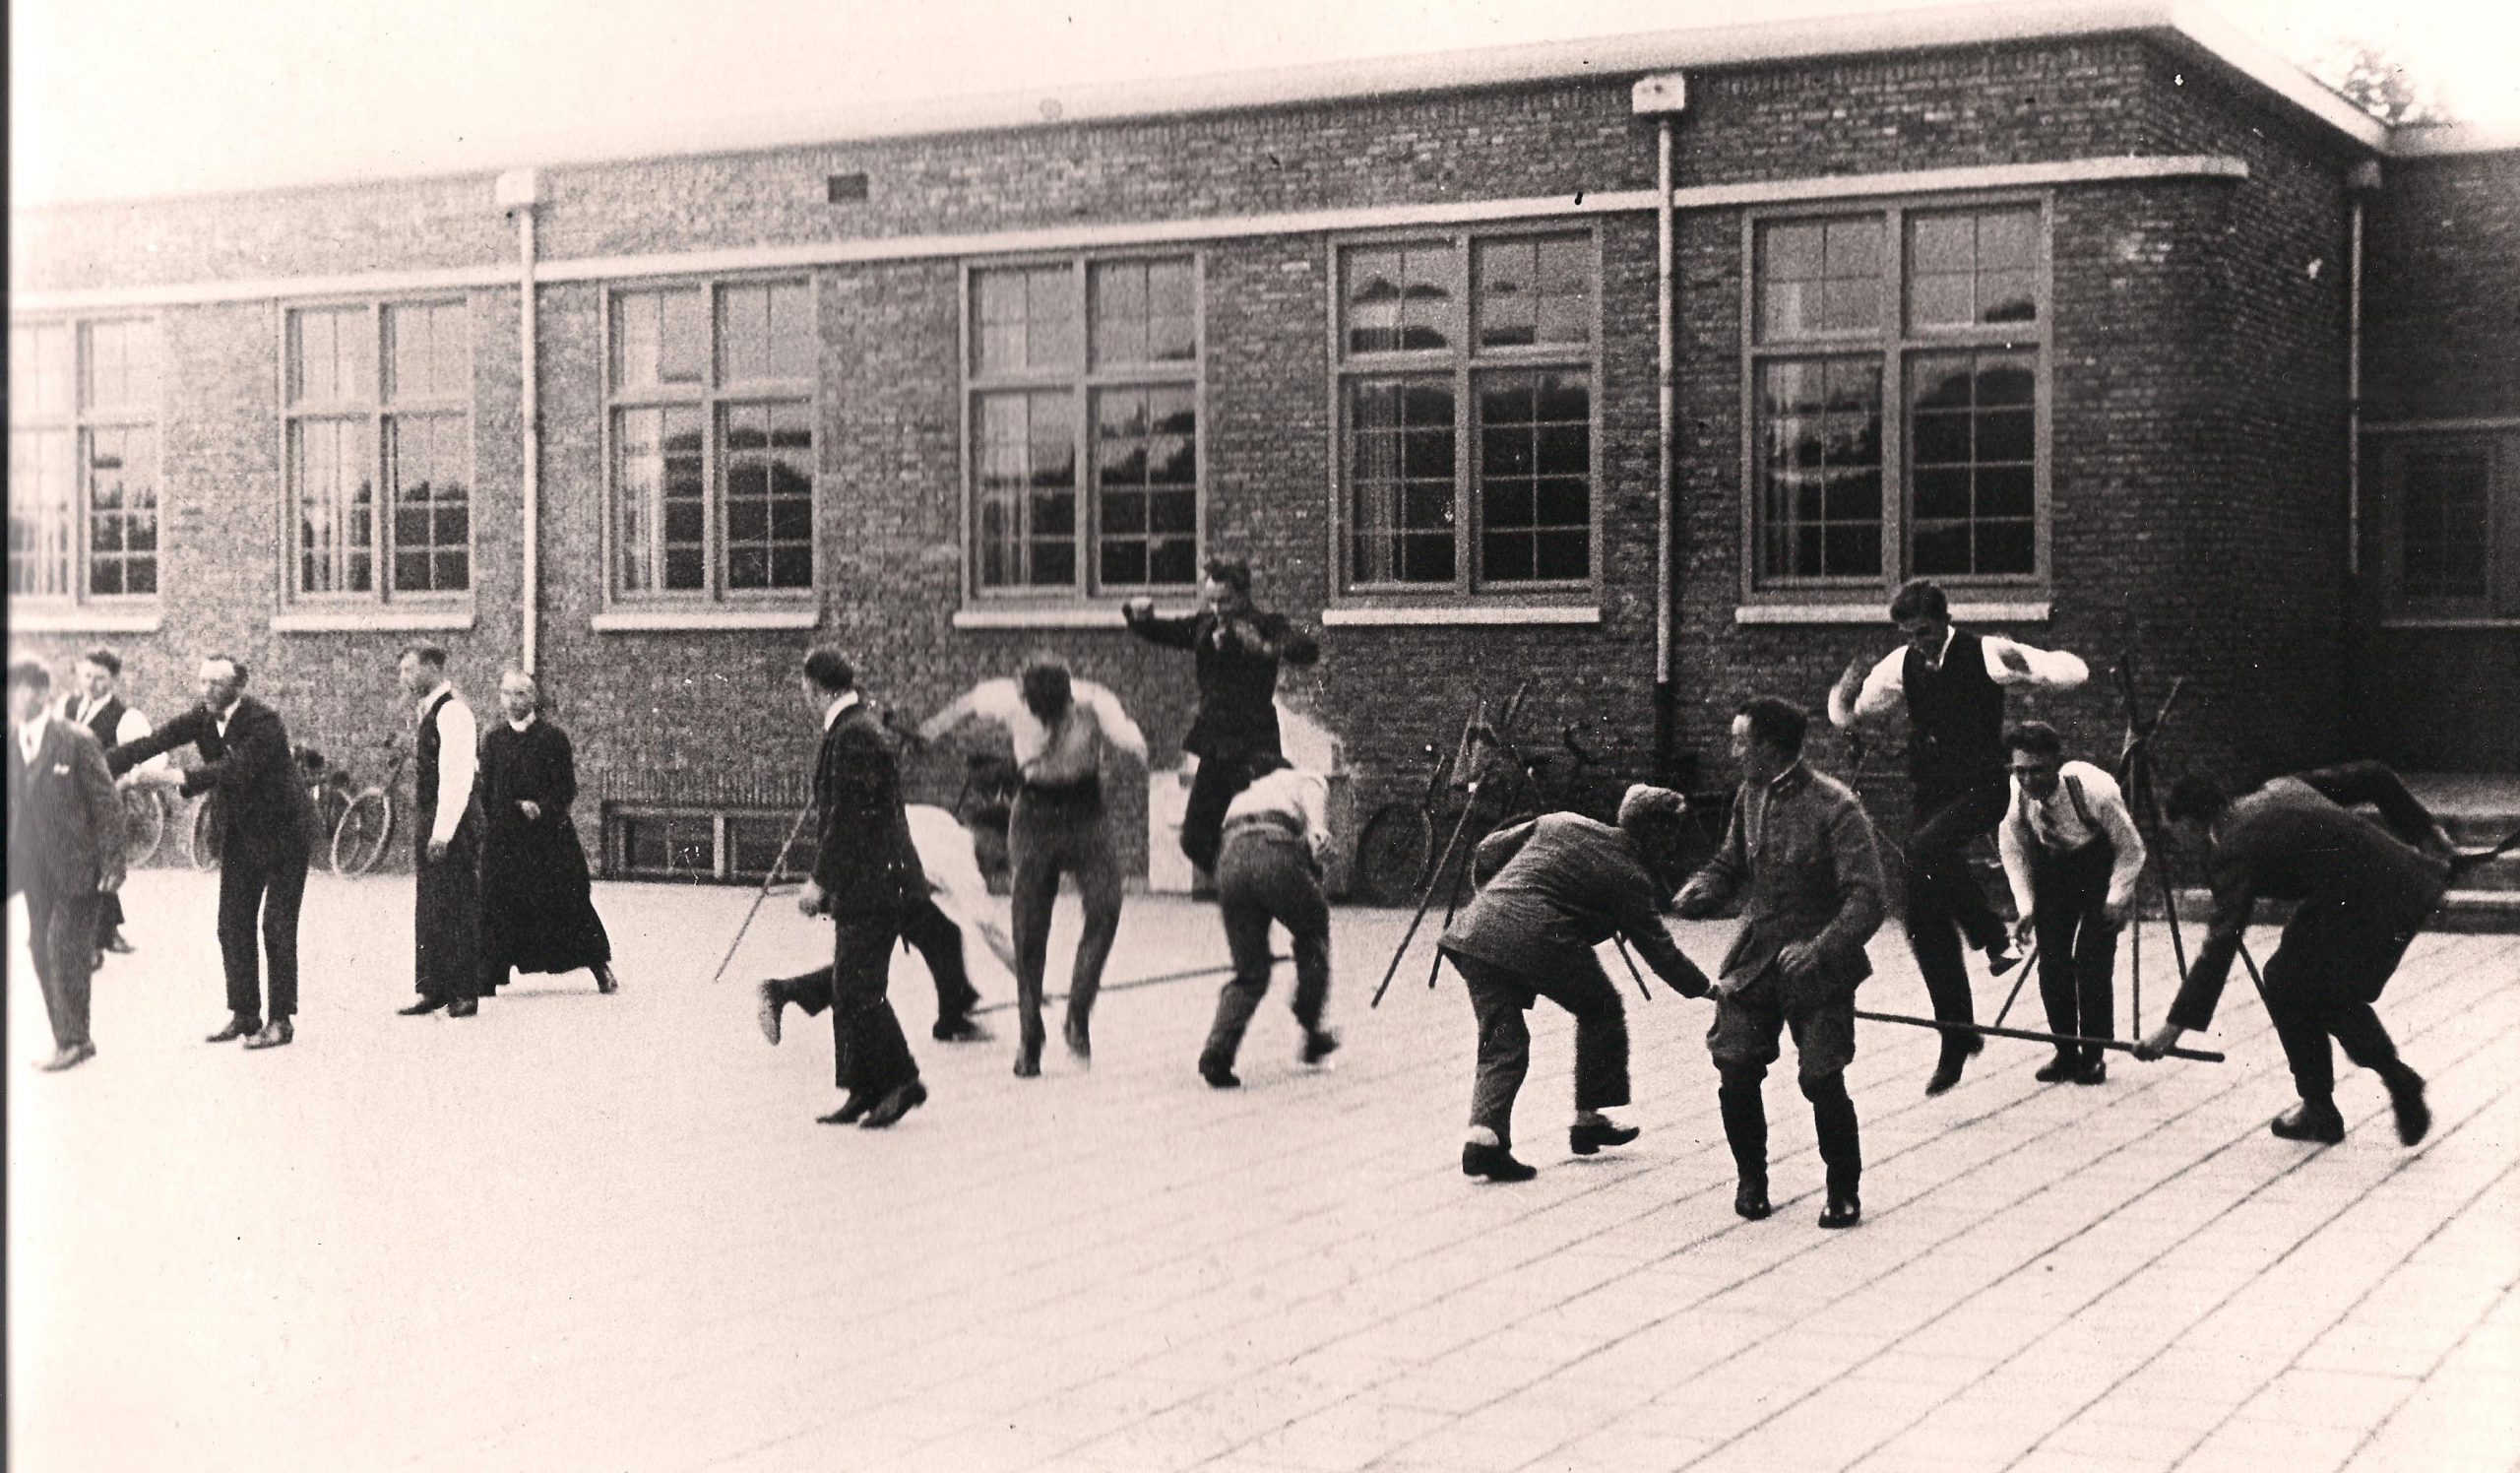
[1444,812,1706,996]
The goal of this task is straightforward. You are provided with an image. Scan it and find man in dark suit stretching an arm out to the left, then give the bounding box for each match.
[106,656,315,1050]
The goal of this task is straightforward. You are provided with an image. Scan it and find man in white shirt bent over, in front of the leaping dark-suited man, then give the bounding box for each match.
[1200,751,1338,1090]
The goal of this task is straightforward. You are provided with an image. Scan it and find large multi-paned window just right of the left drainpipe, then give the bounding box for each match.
[604,280,819,603]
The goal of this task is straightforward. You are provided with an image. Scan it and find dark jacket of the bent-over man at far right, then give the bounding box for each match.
[2170,762,2449,1029]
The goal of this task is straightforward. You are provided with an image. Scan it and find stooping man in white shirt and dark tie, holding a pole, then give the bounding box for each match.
[1996,722,2145,1085]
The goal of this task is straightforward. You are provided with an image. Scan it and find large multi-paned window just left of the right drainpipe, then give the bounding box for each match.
[1336,232,1601,596]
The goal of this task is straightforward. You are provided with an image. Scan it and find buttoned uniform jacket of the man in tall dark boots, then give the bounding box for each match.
[1678,762,1882,1001]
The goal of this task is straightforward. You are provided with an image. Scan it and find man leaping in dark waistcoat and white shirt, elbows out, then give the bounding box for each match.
[1830,578,2092,1095]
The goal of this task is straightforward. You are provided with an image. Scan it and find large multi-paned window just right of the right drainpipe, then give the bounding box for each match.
[1746,202,2048,596]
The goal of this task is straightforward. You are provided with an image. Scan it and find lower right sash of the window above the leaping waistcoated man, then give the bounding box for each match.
[1908,351,2039,578]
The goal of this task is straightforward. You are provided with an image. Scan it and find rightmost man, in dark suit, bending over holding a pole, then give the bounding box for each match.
[2134,762,2452,1145]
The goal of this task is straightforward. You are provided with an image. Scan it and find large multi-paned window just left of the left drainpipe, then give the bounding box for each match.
[284,300,473,603]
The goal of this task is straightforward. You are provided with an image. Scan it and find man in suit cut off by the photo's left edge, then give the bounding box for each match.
[8,661,123,1069]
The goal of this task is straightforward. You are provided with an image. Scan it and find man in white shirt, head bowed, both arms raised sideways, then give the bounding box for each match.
[919,653,1147,1079]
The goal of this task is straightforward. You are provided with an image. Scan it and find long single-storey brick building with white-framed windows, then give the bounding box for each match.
[10,0,2520,872]
